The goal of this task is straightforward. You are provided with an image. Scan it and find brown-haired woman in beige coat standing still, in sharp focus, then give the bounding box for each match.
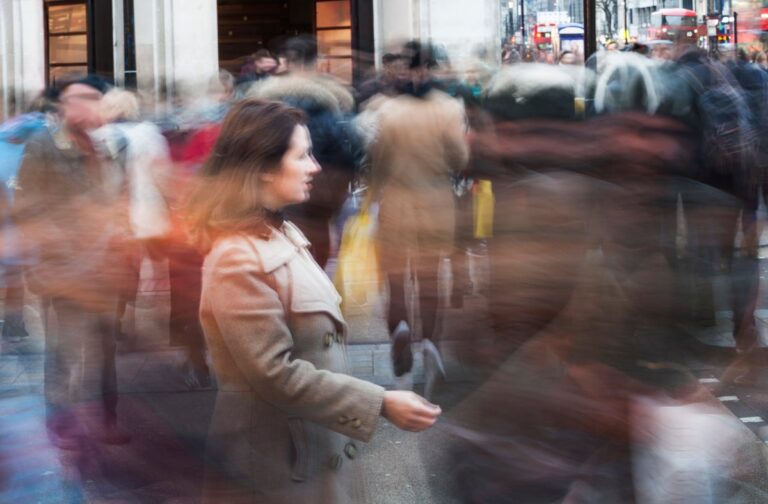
[184,99,441,503]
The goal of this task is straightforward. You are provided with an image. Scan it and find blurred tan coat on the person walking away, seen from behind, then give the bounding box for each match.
[366,90,469,273]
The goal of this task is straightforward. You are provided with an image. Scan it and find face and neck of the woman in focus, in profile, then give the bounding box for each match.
[262,125,320,210]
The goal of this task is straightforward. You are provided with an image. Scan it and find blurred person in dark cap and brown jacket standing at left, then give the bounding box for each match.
[14,76,132,449]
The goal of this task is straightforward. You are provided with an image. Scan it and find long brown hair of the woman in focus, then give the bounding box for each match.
[187,99,306,252]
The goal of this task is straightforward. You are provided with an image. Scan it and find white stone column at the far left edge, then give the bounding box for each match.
[0,0,45,119]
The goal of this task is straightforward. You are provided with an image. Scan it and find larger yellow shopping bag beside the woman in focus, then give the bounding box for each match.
[333,201,381,311]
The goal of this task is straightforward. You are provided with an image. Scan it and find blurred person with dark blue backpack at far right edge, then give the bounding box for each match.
[678,47,768,383]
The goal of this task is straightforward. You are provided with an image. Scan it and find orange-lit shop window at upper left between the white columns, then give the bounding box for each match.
[46,1,88,85]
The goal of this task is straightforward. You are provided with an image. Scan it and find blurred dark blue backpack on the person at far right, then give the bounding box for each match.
[690,62,760,177]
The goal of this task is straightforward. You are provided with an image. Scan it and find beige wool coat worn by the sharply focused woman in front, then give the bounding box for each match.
[200,222,384,504]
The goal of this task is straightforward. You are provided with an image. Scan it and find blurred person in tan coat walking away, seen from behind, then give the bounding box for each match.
[368,42,469,388]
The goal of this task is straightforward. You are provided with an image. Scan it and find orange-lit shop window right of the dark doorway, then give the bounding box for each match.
[315,0,352,82]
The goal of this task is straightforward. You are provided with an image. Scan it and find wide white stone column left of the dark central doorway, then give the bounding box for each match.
[134,0,219,107]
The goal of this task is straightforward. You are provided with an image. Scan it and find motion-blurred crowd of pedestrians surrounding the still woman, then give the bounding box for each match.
[0,33,768,503]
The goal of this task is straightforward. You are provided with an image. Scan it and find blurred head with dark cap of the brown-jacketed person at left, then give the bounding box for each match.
[59,76,109,131]
